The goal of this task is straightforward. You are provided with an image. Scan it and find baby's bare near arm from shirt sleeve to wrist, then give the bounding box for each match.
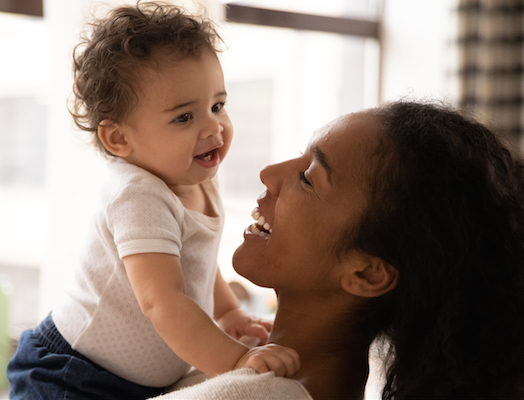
[124,253,296,376]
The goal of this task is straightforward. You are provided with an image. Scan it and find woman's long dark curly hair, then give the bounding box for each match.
[357,101,524,399]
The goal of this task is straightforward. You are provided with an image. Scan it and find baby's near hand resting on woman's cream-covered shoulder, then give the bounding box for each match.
[235,344,300,378]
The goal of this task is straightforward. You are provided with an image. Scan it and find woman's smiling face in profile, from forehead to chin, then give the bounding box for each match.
[233,113,381,294]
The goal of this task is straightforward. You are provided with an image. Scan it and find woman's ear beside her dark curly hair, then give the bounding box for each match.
[340,250,398,297]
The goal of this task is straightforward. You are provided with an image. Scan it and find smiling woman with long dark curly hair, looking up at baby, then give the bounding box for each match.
[151,102,524,400]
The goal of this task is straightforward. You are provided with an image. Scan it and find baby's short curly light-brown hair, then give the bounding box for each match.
[69,1,221,156]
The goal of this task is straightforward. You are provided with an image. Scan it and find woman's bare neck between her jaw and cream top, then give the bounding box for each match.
[269,299,371,400]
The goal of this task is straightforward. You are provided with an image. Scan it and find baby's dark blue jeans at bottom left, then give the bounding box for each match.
[7,315,163,400]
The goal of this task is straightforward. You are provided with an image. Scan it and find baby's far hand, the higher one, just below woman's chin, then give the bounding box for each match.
[217,308,273,344]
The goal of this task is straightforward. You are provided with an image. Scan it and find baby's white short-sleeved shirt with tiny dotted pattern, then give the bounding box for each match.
[52,159,223,387]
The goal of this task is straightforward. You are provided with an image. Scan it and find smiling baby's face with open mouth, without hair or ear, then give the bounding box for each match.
[121,49,233,193]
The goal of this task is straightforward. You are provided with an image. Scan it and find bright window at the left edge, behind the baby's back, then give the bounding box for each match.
[0,11,49,337]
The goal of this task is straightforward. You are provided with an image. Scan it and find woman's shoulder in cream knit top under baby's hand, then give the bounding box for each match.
[151,368,313,400]
